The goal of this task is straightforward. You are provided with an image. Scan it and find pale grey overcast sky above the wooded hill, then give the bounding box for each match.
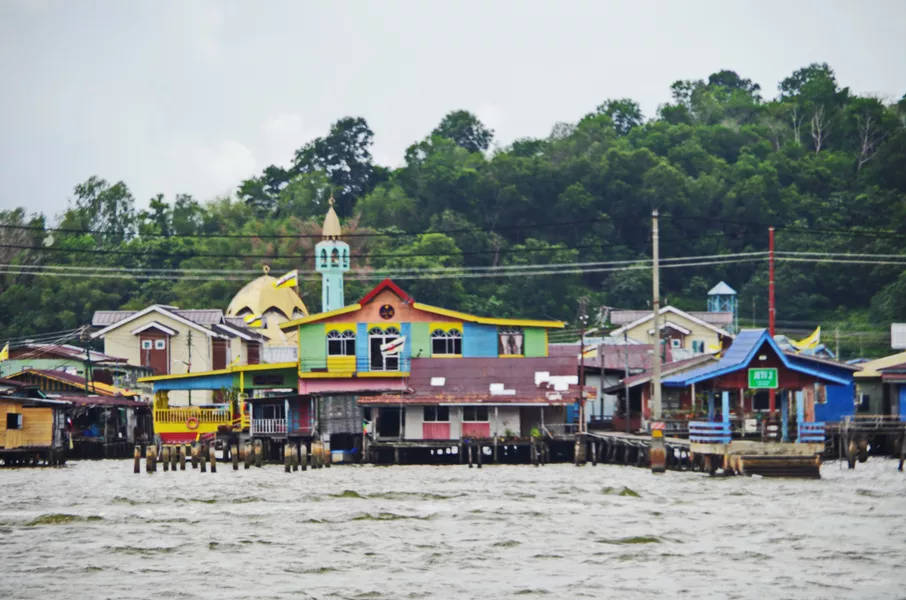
[0,0,906,217]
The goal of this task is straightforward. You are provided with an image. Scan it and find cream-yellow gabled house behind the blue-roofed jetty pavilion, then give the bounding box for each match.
[610,306,733,360]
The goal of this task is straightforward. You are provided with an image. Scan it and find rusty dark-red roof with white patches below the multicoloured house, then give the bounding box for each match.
[359,357,594,405]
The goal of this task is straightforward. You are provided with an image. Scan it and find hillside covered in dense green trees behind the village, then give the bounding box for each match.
[0,64,906,356]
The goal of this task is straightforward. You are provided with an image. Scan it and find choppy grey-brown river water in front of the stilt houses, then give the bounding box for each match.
[0,457,906,600]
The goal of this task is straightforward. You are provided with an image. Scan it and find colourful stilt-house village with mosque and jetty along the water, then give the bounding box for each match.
[0,202,906,477]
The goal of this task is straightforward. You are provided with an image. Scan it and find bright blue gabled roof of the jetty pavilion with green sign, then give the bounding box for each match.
[661,329,852,387]
